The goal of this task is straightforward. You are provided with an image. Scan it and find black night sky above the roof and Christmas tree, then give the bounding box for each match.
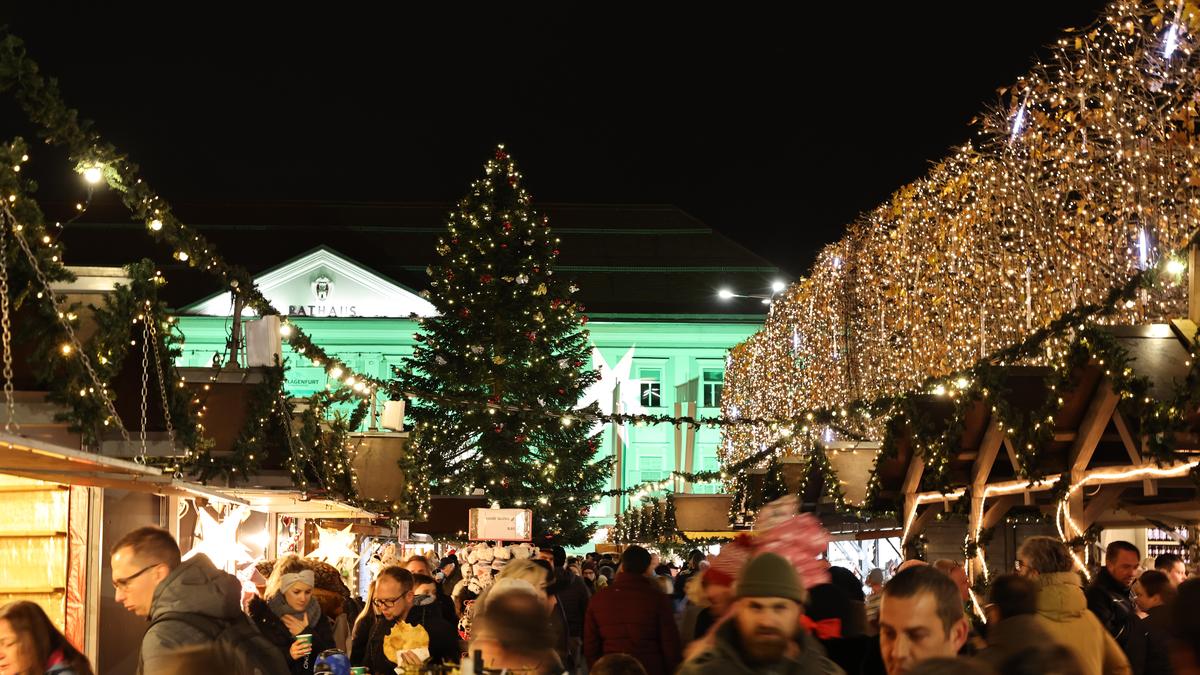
[0,0,1103,274]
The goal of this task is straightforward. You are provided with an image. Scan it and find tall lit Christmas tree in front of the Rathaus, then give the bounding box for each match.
[396,145,611,545]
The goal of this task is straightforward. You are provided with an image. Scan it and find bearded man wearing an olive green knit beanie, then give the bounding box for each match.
[678,552,844,675]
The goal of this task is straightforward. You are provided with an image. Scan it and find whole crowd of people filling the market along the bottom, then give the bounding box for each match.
[0,527,1200,675]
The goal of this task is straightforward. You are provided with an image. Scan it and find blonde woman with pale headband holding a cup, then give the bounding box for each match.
[248,554,334,675]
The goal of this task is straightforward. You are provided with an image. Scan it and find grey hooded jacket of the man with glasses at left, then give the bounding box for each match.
[138,555,246,675]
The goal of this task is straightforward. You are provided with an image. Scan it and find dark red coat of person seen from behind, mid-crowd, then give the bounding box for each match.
[583,572,682,675]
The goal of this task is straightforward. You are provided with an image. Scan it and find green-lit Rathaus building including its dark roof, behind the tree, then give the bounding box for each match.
[67,199,779,536]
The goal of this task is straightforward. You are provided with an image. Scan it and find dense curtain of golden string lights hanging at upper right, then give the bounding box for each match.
[720,0,1200,470]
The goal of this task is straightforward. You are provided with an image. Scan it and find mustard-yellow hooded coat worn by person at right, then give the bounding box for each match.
[1036,572,1130,675]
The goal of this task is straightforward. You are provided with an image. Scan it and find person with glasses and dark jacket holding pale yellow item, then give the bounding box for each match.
[350,566,461,673]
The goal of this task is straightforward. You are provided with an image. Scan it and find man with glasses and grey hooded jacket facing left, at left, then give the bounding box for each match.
[112,527,258,675]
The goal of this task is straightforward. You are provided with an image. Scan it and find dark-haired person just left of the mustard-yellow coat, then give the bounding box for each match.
[976,574,1055,671]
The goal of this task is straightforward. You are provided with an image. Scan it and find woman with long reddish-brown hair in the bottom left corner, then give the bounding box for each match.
[0,601,92,675]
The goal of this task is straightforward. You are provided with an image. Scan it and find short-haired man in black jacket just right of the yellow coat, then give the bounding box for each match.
[1086,540,1147,675]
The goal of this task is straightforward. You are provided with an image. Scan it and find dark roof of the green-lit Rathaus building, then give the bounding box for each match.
[47,196,780,319]
